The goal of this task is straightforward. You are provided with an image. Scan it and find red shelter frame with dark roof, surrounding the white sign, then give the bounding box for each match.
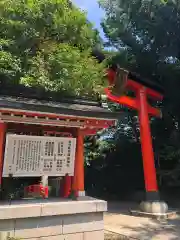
[0,84,118,197]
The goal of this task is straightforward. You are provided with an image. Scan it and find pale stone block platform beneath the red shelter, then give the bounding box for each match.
[0,199,107,240]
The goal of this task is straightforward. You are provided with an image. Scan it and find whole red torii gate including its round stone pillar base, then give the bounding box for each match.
[105,69,167,213]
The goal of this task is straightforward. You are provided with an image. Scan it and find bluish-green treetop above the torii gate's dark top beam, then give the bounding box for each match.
[100,0,180,103]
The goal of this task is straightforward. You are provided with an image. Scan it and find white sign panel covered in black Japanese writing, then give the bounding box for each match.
[3,134,76,177]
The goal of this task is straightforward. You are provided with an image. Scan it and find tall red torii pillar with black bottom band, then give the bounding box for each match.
[138,87,159,200]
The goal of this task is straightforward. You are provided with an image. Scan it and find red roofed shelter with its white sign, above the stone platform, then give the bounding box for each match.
[0,84,118,197]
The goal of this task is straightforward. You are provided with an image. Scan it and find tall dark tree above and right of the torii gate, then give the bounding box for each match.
[97,0,180,188]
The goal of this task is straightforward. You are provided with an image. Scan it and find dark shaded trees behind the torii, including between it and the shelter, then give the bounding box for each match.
[85,0,180,194]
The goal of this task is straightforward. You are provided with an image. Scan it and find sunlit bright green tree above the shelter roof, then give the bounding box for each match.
[0,0,104,96]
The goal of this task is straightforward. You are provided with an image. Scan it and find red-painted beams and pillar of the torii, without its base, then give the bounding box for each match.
[105,69,163,192]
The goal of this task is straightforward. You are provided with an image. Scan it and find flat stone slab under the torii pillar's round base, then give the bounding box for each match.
[130,210,177,220]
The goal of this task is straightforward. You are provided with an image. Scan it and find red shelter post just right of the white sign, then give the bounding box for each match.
[72,129,85,197]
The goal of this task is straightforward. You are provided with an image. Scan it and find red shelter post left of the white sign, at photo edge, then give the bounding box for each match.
[0,122,6,187]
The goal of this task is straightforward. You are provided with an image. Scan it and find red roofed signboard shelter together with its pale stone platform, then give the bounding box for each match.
[0,86,109,240]
